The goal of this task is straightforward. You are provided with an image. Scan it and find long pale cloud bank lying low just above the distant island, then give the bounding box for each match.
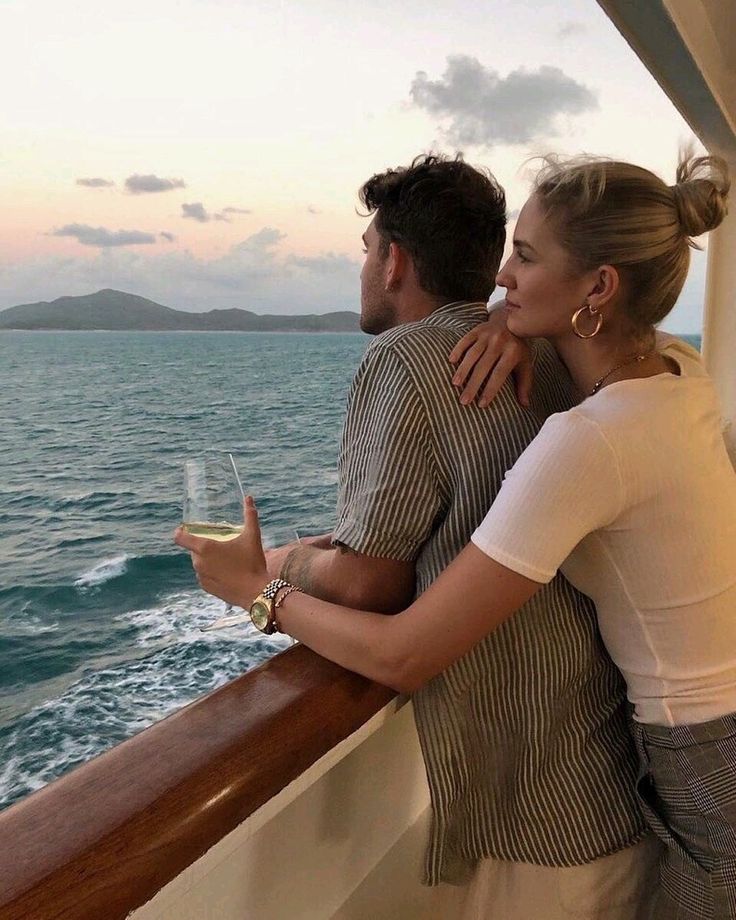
[0,227,360,315]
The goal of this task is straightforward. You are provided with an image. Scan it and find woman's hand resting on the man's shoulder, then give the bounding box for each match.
[450,310,534,406]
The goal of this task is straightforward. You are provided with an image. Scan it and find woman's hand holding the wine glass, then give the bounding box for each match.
[174,496,269,610]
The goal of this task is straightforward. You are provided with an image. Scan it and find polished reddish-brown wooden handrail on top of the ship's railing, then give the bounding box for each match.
[0,645,395,920]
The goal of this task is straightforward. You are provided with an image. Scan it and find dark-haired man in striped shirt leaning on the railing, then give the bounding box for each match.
[185,156,650,920]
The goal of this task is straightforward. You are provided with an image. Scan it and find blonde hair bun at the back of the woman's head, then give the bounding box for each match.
[672,154,731,236]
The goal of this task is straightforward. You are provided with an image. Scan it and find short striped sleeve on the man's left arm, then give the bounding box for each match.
[333,341,440,561]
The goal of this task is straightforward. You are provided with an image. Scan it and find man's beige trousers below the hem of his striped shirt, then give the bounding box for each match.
[457,835,661,920]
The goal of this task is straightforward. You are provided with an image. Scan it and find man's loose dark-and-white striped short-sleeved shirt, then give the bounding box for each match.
[334,303,644,884]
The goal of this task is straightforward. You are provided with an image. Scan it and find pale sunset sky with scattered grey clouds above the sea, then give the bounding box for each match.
[0,0,705,332]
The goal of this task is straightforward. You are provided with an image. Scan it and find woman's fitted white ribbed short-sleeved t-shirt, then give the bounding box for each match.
[472,340,736,725]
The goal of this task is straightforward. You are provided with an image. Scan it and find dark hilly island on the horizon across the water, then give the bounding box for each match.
[0,288,360,332]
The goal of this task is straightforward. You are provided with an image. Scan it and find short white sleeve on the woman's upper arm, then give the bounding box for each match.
[471,410,623,583]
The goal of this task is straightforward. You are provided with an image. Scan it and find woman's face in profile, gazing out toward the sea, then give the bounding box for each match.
[496,195,595,338]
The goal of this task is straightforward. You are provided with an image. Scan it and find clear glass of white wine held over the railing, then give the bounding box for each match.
[182,453,248,629]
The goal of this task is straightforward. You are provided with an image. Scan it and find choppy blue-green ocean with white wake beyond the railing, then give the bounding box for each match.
[0,332,699,808]
